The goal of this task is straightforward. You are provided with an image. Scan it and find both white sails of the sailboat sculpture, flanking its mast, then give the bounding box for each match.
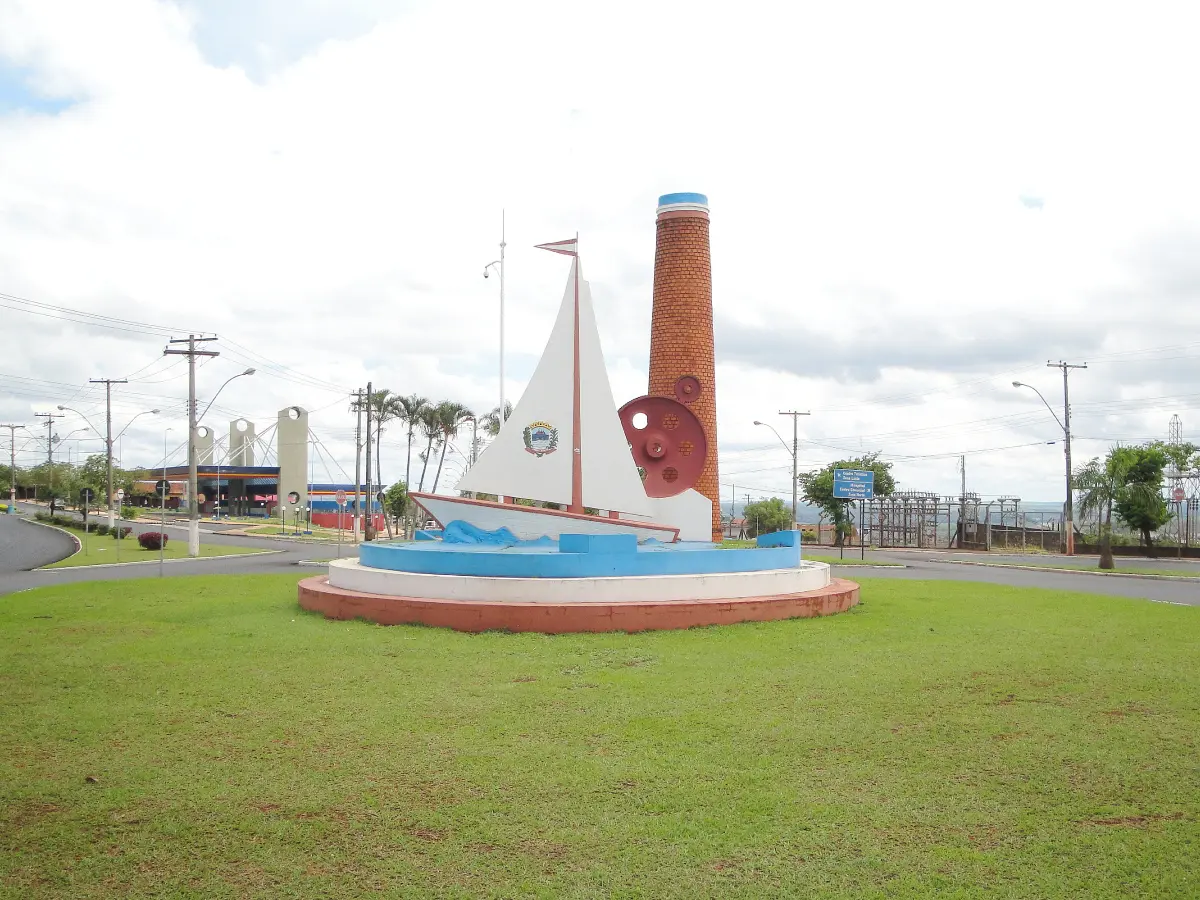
[457,257,652,516]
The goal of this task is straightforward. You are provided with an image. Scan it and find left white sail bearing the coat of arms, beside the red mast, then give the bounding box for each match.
[458,259,578,505]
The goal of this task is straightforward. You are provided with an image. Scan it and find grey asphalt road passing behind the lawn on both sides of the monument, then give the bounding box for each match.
[0,508,1200,606]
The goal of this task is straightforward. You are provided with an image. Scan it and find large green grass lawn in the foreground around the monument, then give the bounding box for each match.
[0,576,1200,899]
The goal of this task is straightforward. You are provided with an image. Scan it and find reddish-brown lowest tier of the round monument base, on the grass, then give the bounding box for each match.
[299,575,858,635]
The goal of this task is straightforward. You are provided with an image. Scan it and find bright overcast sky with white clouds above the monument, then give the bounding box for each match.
[0,0,1200,500]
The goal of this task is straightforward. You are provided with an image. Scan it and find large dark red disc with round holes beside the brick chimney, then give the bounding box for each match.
[618,397,708,497]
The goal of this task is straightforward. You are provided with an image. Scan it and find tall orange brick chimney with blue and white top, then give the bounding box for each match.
[648,193,722,541]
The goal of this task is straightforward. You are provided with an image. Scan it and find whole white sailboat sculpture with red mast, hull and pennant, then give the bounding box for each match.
[409,239,679,541]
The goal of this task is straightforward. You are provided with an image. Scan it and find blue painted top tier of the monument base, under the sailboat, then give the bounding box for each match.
[359,527,800,578]
